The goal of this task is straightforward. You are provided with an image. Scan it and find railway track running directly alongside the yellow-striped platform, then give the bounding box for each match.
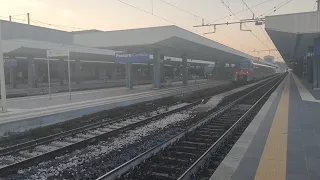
[97,75,284,180]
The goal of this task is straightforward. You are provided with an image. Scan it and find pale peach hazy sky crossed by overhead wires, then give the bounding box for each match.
[0,0,316,60]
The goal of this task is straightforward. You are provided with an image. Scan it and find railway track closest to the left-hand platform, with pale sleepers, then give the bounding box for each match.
[0,79,248,177]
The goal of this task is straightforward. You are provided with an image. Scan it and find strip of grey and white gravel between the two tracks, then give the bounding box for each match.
[6,110,198,180]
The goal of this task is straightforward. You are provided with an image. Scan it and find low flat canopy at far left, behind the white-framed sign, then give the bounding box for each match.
[2,39,117,61]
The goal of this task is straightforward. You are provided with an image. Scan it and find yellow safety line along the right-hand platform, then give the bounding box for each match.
[255,77,290,180]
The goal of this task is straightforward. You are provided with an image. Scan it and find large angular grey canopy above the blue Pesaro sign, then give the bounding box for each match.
[74,26,252,62]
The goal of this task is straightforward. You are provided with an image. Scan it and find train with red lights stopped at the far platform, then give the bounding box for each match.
[232,59,278,82]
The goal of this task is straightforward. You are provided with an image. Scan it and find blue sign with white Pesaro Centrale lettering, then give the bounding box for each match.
[116,53,151,63]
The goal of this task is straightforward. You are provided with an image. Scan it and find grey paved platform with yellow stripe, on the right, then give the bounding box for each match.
[210,73,320,180]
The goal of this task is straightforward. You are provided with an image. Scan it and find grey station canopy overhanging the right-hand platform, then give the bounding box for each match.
[266,11,320,62]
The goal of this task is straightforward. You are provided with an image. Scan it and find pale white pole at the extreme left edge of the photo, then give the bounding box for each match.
[0,21,7,112]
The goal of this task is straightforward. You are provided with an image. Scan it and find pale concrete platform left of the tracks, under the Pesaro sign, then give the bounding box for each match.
[0,80,230,136]
